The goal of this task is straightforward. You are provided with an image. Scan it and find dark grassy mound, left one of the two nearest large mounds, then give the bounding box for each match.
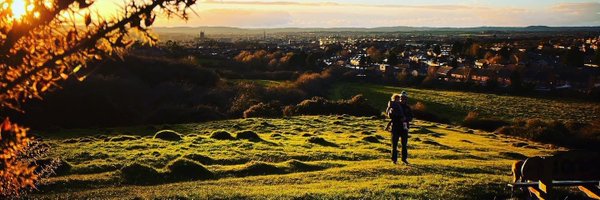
[120,163,164,185]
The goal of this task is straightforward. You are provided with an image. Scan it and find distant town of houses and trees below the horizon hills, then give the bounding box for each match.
[144,27,600,94]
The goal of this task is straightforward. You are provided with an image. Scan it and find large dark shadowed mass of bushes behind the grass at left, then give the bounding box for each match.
[11,55,223,129]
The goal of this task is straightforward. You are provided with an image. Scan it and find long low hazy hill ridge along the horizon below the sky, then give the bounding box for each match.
[154,26,600,35]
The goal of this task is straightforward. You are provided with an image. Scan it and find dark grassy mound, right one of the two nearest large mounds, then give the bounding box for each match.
[167,158,215,180]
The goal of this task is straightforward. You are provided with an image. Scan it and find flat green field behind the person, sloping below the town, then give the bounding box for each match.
[329,83,600,122]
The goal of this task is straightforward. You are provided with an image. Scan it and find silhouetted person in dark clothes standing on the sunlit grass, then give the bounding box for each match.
[386,91,412,165]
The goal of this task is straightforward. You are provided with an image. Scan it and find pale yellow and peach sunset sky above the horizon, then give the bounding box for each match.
[96,0,600,28]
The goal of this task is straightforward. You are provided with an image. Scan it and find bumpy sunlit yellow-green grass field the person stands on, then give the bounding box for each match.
[26,115,558,199]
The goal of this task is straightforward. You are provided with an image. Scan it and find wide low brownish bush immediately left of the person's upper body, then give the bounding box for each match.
[284,94,379,116]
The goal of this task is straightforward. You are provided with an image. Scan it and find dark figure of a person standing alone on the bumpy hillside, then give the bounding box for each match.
[385,94,406,164]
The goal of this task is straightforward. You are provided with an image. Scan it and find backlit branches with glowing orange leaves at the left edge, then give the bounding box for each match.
[0,0,196,196]
